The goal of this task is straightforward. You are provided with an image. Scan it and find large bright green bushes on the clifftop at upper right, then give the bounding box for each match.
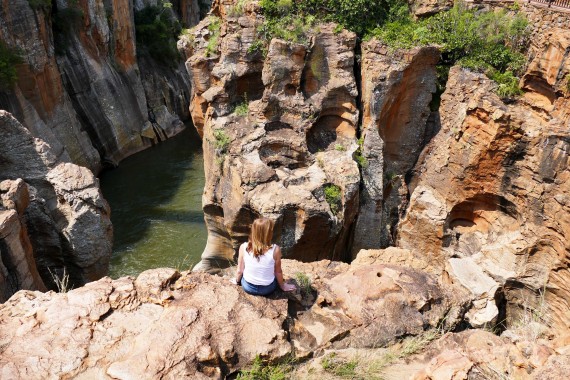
[368,2,529,98]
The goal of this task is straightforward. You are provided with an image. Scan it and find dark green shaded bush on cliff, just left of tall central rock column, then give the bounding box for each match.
[135,1,182,66]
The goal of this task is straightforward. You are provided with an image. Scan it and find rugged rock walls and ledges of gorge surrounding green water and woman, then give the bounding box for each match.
[0,0,570,379]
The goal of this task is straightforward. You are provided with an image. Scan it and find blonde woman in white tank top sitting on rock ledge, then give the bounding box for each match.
[236,218,295,296]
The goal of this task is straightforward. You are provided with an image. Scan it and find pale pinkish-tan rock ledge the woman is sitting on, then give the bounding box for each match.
[0,255,461,379]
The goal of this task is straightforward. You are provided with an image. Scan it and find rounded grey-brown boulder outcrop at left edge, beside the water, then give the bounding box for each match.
[0,111,112,296]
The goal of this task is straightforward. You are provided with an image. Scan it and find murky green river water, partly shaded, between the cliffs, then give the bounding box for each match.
[100,126,207,278]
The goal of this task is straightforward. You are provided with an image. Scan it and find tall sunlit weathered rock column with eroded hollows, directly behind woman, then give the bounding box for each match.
[181,1,359,270]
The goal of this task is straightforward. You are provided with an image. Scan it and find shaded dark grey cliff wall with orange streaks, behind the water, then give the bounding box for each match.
[0,0,199,172]
